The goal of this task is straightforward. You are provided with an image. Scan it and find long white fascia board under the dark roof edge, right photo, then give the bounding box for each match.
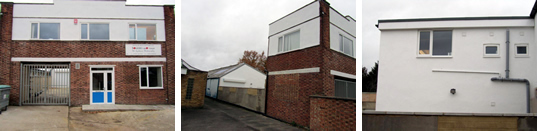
[379,19,534,30]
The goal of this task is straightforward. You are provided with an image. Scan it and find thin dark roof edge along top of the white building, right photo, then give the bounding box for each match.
[378,16,533,23]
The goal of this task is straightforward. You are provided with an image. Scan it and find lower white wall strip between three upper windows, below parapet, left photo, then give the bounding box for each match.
[12,18,166,41]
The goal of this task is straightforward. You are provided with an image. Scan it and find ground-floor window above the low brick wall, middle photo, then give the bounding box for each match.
[334,79,356,99]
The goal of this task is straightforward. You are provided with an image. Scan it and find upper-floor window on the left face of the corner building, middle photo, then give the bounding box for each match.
[278,31,300,52]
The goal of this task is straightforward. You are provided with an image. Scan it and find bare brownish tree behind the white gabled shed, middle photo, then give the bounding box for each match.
[237,50,267,73]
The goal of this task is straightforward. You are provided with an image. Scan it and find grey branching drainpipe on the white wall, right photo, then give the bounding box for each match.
[491,29,531,113]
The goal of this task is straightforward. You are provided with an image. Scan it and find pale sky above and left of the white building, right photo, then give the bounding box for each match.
[362,0,535,70]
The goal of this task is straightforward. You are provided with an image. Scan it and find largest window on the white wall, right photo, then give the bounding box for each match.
[418,30,452,56]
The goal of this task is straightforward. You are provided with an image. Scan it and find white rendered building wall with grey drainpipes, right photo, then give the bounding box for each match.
[376,16,537,113]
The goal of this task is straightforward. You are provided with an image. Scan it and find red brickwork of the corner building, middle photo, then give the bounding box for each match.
[267,0,356,127]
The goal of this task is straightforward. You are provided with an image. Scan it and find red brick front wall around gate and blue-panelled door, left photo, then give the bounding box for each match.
[0,3,175,106]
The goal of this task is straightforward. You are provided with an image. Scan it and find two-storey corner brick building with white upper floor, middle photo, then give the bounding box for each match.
[266,0,357,130]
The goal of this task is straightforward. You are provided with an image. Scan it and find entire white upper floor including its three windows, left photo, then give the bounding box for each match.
[12,0,172,41]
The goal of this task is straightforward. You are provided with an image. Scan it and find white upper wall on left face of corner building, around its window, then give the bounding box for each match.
[267,2,319,56]
